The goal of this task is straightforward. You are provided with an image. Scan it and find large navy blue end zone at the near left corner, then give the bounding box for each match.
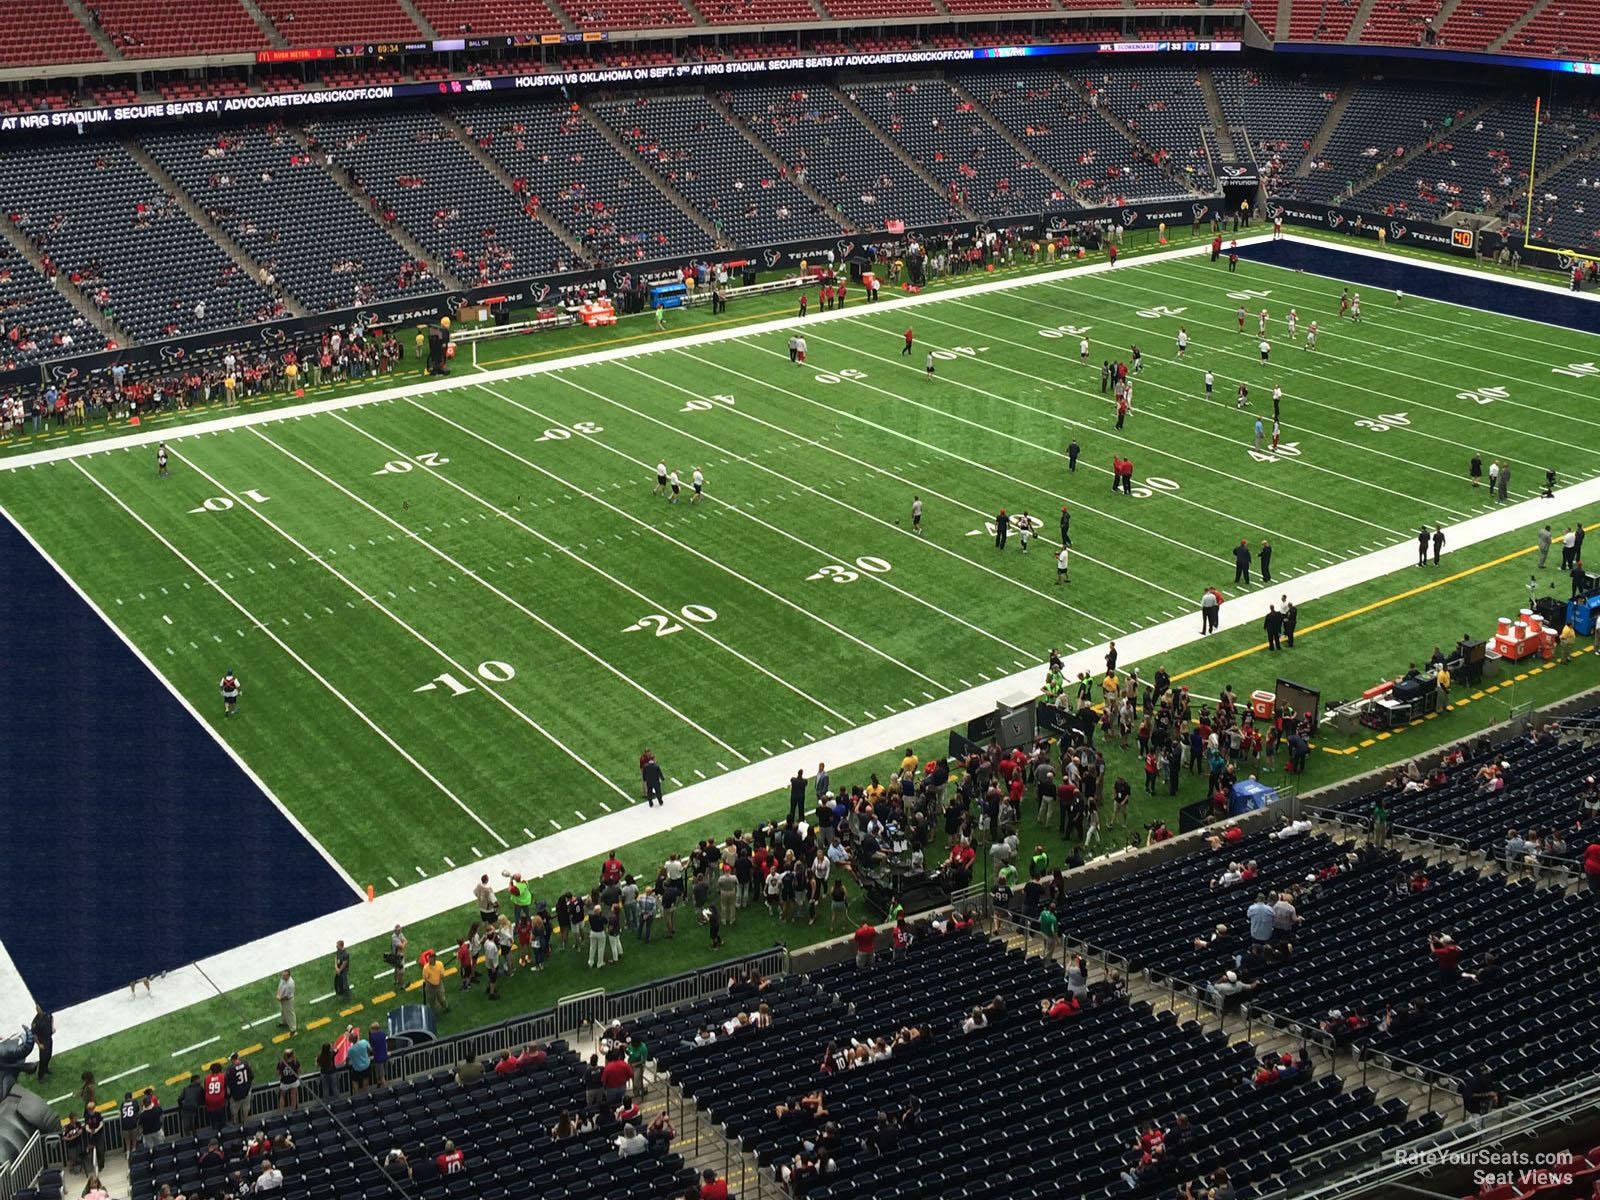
[0,517,357,1026]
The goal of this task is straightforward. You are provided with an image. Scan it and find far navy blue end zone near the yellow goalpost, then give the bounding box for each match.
[1229,238,1600,336]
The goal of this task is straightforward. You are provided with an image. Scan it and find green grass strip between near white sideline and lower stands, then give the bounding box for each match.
[24,499,1600,1114]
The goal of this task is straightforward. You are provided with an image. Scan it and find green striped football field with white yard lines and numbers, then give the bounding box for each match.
[0,244,1600,891]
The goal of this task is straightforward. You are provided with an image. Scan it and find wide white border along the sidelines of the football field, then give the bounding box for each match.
[0,234,1600,1053]
